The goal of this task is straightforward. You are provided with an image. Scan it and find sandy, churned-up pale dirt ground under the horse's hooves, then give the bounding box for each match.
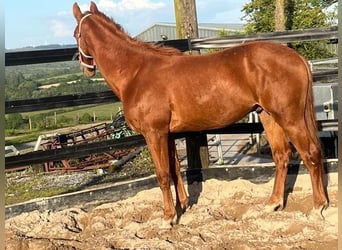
[5,173,338,250]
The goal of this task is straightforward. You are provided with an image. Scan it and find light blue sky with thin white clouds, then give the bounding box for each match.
[5,0,249,49]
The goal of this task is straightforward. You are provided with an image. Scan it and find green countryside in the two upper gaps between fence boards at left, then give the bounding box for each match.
[5,57,121,137]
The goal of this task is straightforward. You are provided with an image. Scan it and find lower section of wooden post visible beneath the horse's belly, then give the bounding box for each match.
[185,133,209,169]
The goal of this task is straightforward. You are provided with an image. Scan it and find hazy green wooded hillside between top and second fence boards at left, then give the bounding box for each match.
[5,62,109,101]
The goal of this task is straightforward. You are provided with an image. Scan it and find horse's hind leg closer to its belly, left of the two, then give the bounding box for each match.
[259,112,291,211]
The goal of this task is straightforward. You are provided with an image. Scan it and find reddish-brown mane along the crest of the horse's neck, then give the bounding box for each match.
[93,11,184,55]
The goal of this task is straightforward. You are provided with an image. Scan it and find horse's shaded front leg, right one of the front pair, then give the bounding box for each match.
[169,135,188,219]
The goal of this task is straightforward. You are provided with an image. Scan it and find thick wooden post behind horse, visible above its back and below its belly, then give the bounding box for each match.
[174,0,209,169]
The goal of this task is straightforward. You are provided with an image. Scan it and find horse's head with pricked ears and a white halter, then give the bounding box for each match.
[73,2,98,77]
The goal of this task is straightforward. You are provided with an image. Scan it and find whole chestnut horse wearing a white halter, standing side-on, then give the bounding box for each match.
[73,2,328,227]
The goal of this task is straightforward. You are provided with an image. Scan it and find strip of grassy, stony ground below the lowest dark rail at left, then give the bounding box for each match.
[5,148,154,205]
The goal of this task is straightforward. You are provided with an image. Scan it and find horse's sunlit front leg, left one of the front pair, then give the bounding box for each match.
[144,131,176,229]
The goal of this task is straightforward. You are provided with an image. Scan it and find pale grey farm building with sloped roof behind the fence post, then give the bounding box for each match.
[135,23,244,42]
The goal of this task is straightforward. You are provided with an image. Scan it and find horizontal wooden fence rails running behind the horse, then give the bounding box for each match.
[5,27,337,169]
